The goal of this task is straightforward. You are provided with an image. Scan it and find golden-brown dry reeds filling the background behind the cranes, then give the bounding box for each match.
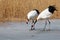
[0,0,60,21]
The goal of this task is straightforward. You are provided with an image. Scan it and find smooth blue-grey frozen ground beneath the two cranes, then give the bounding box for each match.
[0,19,60,40]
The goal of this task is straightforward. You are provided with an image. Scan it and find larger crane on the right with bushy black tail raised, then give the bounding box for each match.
[31,5,57,30]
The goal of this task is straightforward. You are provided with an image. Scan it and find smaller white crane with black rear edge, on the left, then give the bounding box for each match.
[26,9,39,30]
